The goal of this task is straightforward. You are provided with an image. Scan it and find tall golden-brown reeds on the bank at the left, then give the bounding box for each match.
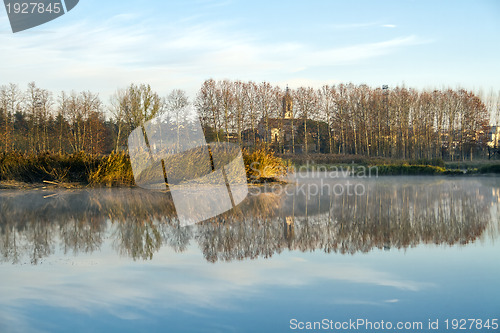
[0,149,287,189]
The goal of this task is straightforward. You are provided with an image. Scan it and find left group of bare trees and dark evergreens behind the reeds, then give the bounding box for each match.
[0,82,113,154]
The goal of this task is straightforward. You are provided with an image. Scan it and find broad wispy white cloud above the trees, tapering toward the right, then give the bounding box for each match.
[0,11,423,101]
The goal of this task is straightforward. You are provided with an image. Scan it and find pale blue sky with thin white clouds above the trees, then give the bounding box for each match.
[0,0,500,101]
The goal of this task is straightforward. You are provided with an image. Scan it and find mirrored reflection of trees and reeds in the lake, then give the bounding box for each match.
[0,177,500,264]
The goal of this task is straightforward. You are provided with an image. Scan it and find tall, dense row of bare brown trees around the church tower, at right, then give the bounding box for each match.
[195,80,494,160]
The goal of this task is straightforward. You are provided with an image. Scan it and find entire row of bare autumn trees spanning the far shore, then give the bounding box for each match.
[0,79,500,160]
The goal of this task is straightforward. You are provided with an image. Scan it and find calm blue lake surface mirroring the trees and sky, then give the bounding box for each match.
[0,175,500,332]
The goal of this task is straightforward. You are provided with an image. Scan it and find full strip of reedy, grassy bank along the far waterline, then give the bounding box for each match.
[0,149,500,189]
